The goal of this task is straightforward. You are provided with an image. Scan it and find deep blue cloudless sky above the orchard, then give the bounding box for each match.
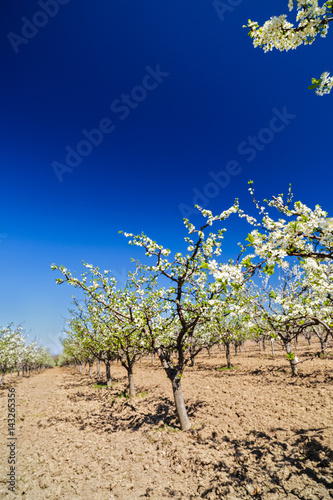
[0,0,333,353]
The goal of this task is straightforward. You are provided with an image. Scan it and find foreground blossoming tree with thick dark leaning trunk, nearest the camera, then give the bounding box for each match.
[119,203,243,430]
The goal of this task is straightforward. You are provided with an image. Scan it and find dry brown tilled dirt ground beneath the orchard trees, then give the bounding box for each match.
[0,343,333,500]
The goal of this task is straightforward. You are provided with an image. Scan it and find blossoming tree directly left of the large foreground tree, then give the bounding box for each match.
[52,263,162,397]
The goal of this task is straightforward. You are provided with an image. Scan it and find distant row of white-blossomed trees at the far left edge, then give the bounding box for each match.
[0,323,54,385]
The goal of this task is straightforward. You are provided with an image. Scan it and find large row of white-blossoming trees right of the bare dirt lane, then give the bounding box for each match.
[52,182,333,429]
